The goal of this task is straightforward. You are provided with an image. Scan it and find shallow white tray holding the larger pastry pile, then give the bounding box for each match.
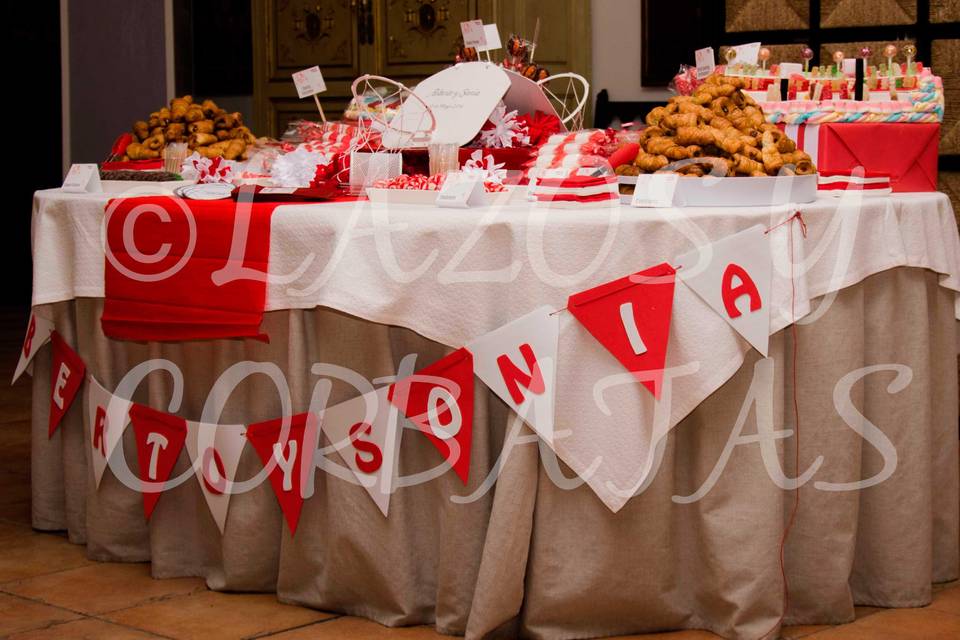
[619,174,817,207]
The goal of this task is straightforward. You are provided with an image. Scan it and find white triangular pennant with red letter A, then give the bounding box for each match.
[677,225,773,356]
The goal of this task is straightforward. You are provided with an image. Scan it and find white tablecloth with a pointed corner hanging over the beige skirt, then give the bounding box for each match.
[33,185,960,511]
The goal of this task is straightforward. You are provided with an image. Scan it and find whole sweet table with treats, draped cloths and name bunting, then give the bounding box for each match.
[17,34,960,639]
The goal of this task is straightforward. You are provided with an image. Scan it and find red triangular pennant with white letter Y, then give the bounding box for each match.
[247,413,319,535]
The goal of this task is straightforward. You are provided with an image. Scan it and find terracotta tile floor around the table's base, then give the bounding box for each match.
[0,311,960,640]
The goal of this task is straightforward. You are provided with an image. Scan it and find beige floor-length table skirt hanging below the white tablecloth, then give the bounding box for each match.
[26,268,958,638]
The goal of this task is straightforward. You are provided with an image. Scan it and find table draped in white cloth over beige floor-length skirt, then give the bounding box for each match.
[24,183,960,638]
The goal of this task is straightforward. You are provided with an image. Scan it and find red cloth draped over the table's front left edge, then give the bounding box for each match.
[100,196,280,341]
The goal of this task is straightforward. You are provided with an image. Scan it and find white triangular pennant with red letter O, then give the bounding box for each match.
[186,421,247,535]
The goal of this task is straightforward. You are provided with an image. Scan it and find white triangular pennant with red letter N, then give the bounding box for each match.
[466,307,560,445]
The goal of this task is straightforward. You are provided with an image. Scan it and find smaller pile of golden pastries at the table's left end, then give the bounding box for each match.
[124,96,256,160]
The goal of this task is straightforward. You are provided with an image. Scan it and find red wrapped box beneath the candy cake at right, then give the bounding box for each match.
[817,122,940,193]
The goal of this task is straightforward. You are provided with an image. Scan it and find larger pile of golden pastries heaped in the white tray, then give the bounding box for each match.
[615,75,817,177]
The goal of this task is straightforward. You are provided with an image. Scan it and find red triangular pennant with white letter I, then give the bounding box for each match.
[567,263,676,398]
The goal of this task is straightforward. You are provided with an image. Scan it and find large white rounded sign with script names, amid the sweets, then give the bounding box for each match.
[383,62,510,149]
